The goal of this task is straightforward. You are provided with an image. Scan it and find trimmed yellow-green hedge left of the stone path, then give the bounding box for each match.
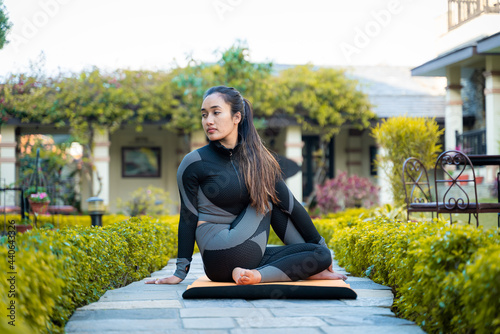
[0,216,178,333]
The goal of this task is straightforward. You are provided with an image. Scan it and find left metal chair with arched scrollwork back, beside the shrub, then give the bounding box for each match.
[403,157,436,221]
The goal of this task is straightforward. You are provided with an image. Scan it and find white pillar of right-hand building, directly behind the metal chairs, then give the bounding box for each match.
[444,67,463,150]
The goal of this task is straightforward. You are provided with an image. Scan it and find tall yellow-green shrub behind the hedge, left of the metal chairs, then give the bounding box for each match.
[372,116,444,206]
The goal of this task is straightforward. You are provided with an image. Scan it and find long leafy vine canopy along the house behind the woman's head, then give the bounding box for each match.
[0,42,375,202]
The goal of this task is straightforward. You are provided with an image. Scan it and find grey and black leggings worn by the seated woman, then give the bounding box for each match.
[196,205,331,282]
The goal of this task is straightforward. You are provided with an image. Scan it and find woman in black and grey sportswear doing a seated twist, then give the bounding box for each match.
[146,86,347,284]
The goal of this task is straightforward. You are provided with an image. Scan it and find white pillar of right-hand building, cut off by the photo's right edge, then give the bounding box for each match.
[484,56,500,155]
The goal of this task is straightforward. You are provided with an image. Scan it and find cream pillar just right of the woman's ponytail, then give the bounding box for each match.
[285,125,304,202]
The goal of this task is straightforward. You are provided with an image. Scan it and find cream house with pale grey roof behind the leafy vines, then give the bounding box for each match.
[0,66,445,212]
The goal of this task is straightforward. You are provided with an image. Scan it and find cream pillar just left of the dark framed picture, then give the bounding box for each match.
[94,130,110,206]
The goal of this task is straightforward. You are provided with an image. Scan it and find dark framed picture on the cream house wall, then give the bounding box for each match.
[122,147,161,177]
